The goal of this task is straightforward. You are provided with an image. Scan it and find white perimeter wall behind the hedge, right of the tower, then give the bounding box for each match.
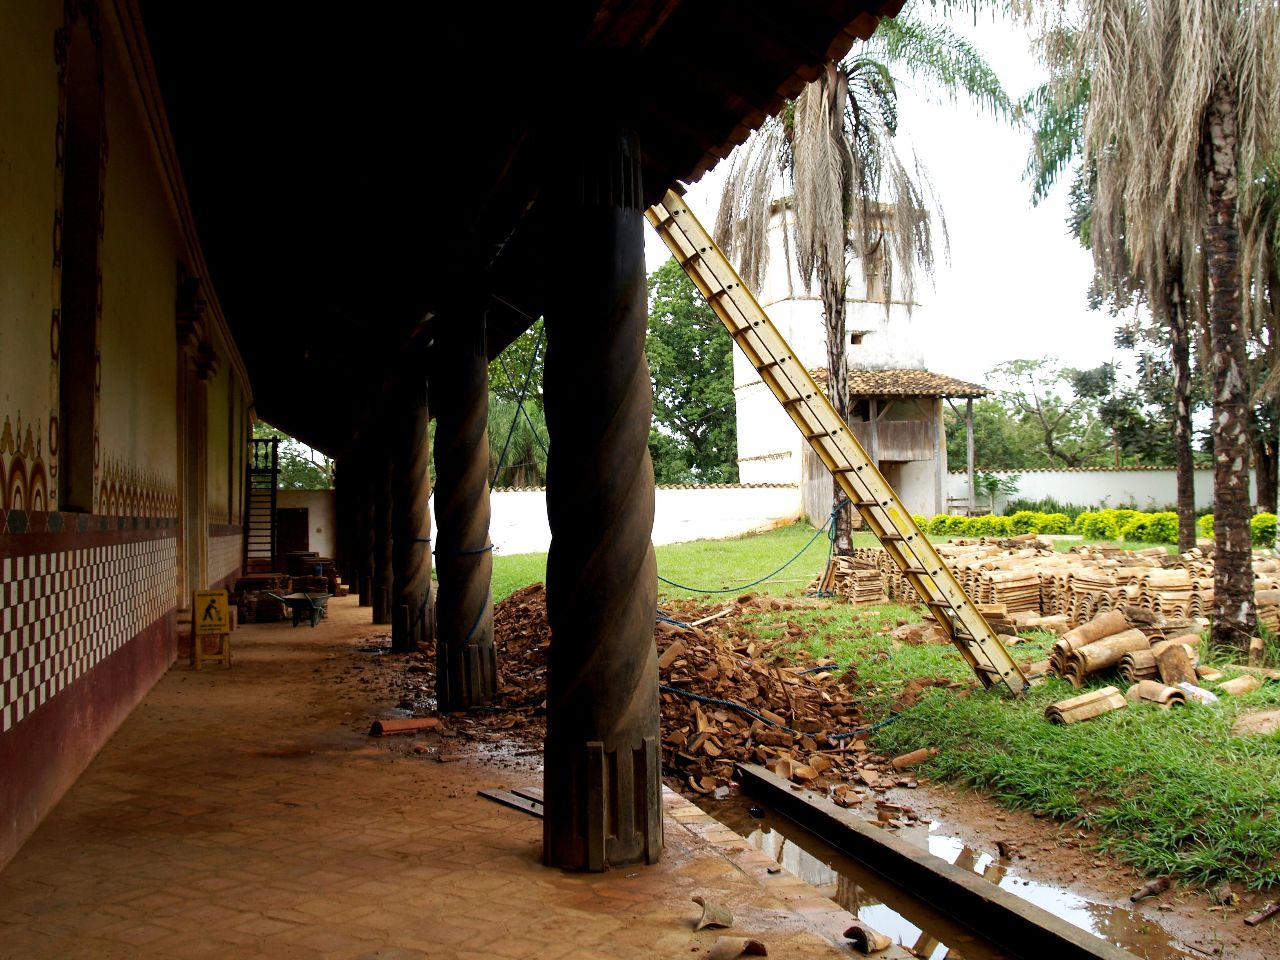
[947,468,1257,509]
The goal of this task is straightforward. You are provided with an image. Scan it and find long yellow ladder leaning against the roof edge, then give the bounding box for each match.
[645,191,1027,694]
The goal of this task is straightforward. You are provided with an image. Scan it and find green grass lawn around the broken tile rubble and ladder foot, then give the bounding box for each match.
[494,524,1280,887]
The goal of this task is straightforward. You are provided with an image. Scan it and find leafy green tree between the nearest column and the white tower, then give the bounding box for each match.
[645,259,737,484]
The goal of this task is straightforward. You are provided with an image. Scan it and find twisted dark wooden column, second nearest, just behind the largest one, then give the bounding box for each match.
[431,323,498,710]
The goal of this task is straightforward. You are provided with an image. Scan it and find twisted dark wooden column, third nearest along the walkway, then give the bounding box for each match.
[392,375,431,653]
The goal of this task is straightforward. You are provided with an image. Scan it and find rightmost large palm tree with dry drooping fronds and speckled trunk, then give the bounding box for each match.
[1076,0,1280,648]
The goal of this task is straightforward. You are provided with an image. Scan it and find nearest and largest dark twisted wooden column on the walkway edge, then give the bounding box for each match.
[543,131,662,870]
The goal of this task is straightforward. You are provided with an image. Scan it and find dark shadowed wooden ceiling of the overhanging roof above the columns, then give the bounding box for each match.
[138,0,902,453]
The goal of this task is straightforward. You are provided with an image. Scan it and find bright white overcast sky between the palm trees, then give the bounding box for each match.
[648,6,1121,383]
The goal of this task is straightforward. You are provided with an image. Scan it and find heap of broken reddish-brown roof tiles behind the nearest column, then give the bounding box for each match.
[442,584,964,803]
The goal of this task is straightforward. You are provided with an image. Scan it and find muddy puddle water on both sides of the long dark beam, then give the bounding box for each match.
[699,796,1203,960]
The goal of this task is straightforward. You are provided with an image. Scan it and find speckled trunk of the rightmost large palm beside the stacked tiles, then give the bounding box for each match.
[1202,78,1256,650]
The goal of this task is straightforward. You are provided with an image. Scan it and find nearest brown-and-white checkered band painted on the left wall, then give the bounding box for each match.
[0,536,177,732]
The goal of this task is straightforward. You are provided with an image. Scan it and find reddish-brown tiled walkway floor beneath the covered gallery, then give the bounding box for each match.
[0,598,890,960]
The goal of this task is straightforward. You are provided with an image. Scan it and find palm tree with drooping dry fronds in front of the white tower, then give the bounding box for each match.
[716,3,1011,554]
